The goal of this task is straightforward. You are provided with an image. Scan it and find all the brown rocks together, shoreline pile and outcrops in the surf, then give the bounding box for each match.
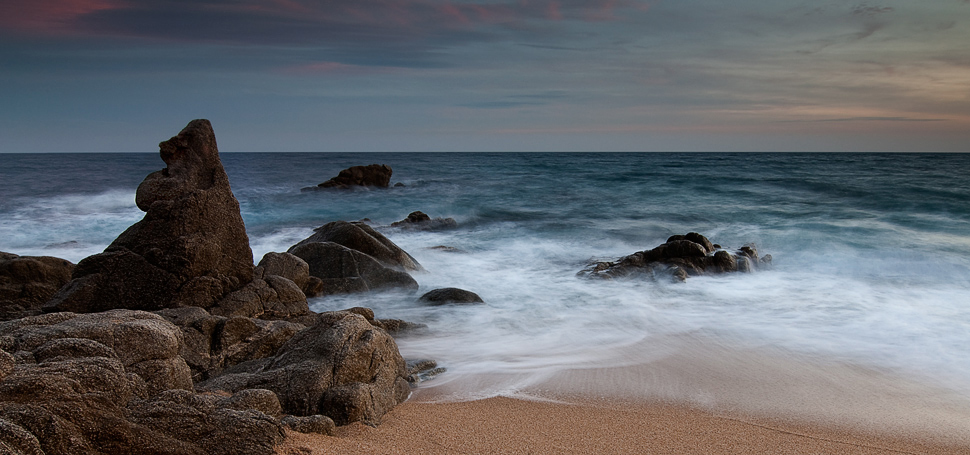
[0,120,770,454]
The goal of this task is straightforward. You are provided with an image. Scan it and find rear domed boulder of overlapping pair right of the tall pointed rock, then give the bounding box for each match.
[288,221,424,272]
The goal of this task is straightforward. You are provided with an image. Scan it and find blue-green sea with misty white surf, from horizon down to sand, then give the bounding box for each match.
[0,153,970,432]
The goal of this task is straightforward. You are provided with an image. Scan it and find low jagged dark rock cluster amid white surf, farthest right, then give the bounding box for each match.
[577,232,771,281]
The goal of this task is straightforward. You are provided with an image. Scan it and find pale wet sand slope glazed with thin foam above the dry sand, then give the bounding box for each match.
[412,336,970,453]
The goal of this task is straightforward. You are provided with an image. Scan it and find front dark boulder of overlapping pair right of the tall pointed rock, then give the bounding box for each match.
[290,242,418,295]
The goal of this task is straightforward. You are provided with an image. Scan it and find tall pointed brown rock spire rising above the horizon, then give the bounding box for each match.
[44,120,253,312]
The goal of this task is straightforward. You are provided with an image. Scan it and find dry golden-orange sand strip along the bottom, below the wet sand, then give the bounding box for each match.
[278,397,970,455]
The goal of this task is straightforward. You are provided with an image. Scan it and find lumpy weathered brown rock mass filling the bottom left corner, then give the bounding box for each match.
[0,310,284,455]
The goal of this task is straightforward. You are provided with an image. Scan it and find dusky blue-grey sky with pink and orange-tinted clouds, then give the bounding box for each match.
[0,0,970,153]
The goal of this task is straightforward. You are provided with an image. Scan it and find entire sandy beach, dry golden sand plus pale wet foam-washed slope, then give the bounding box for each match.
[278,340,970,455]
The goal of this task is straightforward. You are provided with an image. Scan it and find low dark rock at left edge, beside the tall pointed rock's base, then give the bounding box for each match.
[0,252,74,321]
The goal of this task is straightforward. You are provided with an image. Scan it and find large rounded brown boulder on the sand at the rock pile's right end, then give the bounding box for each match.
[198,311,410,425]
